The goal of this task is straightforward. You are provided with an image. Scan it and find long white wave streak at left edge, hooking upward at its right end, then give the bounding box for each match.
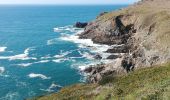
[0,48,37,60]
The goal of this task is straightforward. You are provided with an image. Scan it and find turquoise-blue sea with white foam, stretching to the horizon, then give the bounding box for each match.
[0,5,126,100]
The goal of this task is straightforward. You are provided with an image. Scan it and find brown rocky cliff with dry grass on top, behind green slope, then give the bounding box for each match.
[79,0,170,83]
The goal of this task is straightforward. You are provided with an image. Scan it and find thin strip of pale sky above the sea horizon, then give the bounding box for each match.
[0,0,138,5]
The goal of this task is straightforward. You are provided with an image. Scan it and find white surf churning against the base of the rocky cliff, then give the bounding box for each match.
[54,25,124,83]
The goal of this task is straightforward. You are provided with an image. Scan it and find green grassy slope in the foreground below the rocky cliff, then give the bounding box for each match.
[38,63,170,100]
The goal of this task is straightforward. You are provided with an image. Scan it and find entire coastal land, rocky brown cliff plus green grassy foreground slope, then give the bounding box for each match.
[34,0,170,100]
